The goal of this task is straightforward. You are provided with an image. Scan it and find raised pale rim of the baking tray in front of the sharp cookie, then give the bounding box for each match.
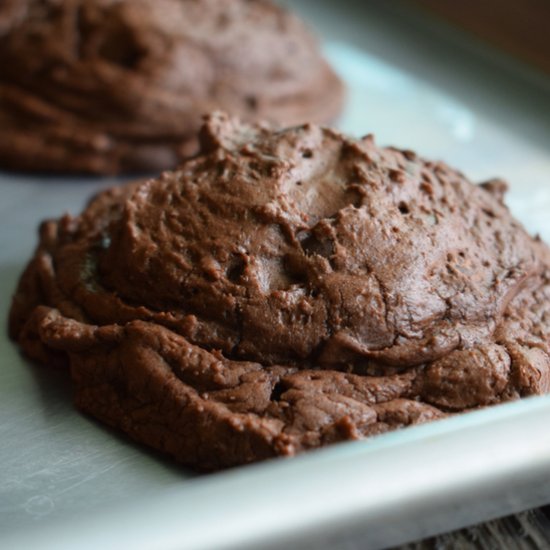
[0,395,550,550]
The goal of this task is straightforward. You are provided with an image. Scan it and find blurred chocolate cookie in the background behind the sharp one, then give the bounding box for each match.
[0,0,343,174]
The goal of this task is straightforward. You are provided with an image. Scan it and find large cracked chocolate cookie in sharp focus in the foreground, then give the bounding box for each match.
[10,114,550,469]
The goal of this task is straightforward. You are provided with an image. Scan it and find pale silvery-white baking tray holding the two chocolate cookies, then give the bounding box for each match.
[0,0,550,550]
